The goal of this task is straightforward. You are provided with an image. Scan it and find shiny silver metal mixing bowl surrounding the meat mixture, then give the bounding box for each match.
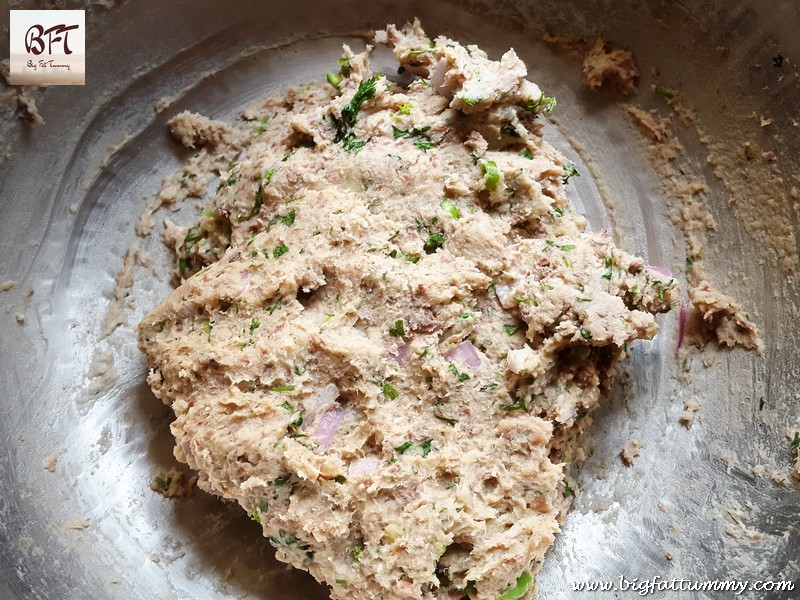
[0,0,800,600]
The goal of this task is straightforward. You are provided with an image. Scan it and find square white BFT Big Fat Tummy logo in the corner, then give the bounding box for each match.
[9,10,86,85]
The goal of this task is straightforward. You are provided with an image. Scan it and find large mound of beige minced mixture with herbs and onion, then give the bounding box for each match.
[138,23,678,600]
